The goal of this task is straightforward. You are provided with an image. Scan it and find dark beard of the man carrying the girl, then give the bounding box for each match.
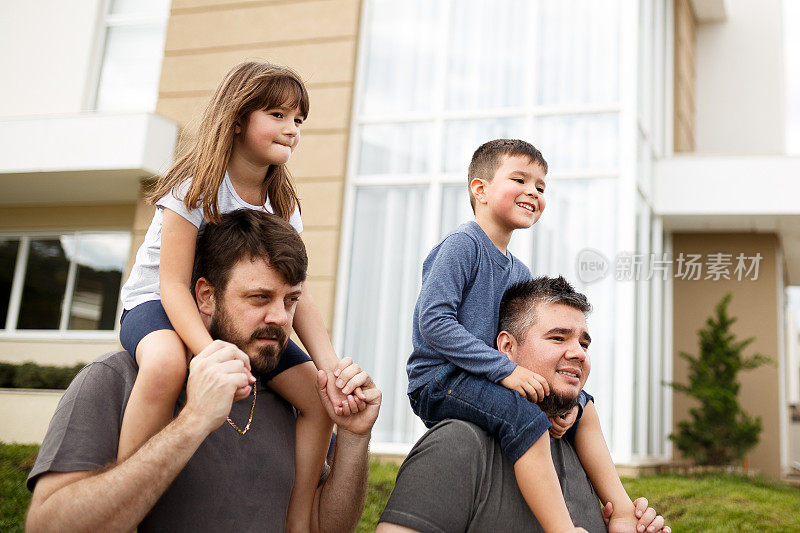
[208,301,288,374]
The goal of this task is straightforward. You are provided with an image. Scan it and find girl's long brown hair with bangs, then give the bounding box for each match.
[147,61,309,222]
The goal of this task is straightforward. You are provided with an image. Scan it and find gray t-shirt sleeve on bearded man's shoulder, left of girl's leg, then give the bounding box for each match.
[27,353,130,491]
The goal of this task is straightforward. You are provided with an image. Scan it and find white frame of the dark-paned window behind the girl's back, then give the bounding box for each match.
[0,229,132,340]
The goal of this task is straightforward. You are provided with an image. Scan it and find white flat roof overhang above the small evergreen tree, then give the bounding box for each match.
[653,156,800,285]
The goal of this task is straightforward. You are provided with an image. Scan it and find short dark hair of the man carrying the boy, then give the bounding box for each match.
[498,276,592,342]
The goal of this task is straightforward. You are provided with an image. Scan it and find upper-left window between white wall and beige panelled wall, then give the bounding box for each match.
[95,0,170,111]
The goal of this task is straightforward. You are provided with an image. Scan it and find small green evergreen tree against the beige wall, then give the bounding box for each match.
[669,292,770,465]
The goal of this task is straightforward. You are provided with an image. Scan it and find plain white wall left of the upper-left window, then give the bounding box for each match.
[0,0,102,117]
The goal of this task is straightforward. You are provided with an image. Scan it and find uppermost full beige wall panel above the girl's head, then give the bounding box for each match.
[166,0,358,52]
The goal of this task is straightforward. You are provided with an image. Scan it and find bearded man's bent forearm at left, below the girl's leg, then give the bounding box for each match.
[27,413,208,531]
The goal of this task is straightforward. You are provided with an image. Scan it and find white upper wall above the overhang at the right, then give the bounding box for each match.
[695,0,785,155]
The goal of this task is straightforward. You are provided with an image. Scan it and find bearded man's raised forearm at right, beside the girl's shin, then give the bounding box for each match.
[312,430,369,533]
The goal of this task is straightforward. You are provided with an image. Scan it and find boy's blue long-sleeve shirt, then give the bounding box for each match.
[406,221,531,392]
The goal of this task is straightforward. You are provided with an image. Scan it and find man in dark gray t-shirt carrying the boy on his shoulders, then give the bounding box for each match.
[377,277,669,533]
